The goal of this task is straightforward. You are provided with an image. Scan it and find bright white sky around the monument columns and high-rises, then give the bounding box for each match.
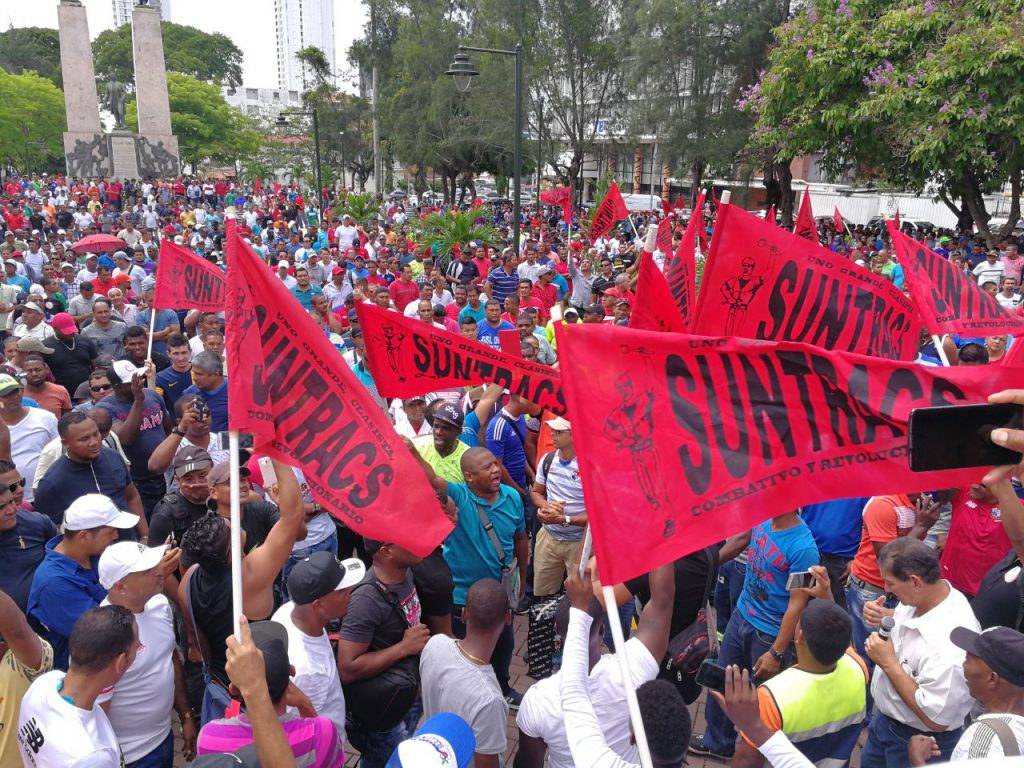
[0,0,367,90]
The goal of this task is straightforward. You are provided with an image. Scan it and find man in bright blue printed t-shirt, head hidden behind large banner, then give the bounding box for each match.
[690,512,819,760]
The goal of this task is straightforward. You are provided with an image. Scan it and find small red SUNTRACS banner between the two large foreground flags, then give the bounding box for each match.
[355,302,565,416]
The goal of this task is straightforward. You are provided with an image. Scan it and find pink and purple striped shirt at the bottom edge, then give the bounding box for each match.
[199,714,345,768]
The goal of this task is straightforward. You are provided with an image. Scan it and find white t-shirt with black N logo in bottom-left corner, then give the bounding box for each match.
[17,670,124,768]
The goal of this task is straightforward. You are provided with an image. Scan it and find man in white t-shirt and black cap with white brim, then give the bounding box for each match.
[272,551,367,737]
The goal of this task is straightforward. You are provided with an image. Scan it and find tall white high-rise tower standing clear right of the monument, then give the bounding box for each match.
[273,0,335,92]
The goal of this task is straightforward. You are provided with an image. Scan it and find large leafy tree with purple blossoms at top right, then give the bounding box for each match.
[743,0,1024,245]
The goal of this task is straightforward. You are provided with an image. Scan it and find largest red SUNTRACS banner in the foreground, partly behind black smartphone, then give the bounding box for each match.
[557,323,1020,584]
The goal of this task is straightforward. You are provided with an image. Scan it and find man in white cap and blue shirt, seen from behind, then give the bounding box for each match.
[28,494,139,670]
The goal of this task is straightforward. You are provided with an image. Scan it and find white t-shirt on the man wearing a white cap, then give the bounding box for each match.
[96,595,177,763]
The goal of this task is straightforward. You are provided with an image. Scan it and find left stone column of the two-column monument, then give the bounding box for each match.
[57,0,110,177]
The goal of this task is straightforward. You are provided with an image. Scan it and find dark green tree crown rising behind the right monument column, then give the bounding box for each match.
[92,22,242,88]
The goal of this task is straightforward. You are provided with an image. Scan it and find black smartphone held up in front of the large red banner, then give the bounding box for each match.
[907,403,1024,472]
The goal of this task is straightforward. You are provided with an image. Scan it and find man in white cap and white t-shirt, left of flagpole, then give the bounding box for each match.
[97,542,199,766]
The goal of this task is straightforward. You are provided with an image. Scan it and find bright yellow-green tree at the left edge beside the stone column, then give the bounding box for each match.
[0,70,67,171]
